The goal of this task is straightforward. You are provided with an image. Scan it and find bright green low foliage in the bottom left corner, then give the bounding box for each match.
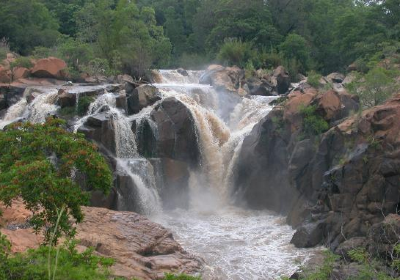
[0,238,114,280]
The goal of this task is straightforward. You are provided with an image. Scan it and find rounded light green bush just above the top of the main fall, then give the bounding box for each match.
[217,39,255,68]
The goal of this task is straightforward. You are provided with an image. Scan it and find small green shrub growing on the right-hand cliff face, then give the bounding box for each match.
[300,105,329,137]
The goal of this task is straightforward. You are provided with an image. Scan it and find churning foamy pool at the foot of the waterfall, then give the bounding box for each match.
[153,206,318,280]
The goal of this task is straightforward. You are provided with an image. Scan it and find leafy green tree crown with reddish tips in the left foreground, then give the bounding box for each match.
[0,118,112,243]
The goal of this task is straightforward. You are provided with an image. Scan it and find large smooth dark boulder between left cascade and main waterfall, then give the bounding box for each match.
[151,97,200,166]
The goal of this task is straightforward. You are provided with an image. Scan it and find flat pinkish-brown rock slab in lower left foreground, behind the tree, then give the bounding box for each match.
[0,203,203,280]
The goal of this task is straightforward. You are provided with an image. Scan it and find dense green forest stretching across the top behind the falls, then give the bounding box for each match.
[0,0,400,76]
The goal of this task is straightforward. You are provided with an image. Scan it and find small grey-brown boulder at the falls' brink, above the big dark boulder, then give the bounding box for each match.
[127,85,161,115]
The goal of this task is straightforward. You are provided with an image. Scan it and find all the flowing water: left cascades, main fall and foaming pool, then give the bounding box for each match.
[0,70,313,280]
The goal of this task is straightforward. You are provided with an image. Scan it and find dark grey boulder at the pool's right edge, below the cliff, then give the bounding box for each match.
[290,222,325,248]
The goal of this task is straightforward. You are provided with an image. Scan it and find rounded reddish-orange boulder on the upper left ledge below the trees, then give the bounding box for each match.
[31,57,67,79]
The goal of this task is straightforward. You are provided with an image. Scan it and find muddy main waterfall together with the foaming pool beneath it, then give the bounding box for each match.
[148,70,318,280]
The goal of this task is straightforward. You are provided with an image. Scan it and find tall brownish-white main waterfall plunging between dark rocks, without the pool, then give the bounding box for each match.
[155,70,274,204]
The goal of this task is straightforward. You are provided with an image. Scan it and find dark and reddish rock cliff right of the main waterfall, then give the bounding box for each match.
[236,79,400,252]
